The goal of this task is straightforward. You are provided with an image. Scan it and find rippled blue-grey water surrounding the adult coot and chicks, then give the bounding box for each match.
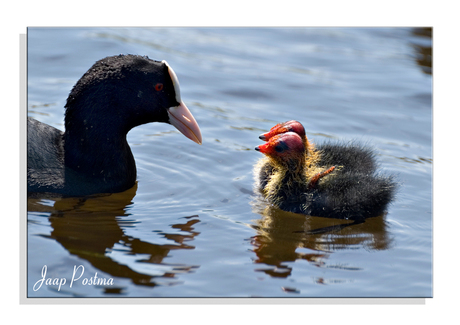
[27,28,432,297]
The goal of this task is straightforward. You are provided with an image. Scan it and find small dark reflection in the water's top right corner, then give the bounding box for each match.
[412,27,433,75]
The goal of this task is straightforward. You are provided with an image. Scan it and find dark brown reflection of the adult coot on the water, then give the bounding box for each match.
[28,182,199,293]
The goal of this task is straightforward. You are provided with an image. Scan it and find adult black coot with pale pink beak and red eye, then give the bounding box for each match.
[27,55,202,196]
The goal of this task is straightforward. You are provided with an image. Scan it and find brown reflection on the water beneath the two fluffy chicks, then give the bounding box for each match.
[251,202,390,278]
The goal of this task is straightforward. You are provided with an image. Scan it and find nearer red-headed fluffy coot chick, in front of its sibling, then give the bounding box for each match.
[255,132,395,220]
